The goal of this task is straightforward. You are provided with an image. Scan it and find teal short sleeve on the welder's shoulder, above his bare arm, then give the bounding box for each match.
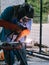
[0,6,14,21]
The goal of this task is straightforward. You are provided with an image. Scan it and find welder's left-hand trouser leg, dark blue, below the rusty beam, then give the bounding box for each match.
[3,50,15,65]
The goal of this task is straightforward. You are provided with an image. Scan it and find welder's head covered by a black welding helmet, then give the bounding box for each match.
[18,3,34,20]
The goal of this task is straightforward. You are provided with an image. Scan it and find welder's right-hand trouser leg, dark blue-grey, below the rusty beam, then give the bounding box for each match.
[14,47,28,65]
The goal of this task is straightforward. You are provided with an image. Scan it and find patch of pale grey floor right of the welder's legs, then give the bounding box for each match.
[28,57,49,65]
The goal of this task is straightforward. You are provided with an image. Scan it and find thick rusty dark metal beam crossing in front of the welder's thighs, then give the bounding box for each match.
[0,43,22,50]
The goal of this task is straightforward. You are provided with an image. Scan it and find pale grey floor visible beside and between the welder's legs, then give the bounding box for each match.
[0,56,49,65]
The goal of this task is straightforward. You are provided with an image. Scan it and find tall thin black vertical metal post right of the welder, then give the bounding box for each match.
[39,0,42,53]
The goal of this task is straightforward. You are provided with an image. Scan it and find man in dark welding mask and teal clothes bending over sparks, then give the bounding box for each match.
[0,3,34,65]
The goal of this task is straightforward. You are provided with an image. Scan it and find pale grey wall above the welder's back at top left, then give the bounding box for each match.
[1,0,25,12]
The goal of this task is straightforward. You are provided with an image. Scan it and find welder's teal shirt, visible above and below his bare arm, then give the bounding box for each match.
[0,6,14,42]
